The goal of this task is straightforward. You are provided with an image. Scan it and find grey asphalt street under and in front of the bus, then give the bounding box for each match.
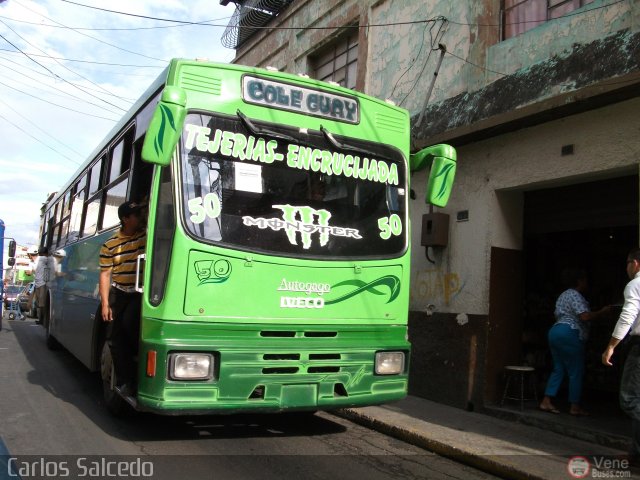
[0,319,495,480]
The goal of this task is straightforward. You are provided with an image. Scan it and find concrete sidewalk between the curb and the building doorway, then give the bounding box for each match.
[340,396,640,480]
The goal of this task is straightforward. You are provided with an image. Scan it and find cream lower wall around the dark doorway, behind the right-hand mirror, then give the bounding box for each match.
[411,98,640,315]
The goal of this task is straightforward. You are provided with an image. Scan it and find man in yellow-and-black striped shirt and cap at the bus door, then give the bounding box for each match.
[100,202,147,395]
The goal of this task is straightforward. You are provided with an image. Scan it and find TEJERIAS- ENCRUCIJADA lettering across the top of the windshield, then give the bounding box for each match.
[185,123,399,185]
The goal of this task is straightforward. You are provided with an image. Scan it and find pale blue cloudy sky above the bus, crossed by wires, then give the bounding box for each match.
[0,0,235,246]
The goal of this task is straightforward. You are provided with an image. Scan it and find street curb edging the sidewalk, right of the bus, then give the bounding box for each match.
[331,408,547,480]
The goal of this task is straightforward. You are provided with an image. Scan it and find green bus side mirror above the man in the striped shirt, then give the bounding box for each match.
[142,86,187,167]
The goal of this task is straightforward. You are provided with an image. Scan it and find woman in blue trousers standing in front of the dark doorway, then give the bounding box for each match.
[540,269,610,416]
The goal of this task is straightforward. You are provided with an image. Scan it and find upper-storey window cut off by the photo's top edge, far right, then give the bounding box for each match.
[502,0,594,40]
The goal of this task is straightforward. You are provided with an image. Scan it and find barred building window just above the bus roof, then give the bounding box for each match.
[310,29,358,88]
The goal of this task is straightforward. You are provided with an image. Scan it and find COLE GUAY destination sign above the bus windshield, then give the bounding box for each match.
[242,75,360,123]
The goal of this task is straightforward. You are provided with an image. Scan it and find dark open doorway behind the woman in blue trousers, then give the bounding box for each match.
[522,175,638,401]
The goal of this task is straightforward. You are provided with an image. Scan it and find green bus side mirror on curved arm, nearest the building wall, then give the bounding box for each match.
[410,144,457,207]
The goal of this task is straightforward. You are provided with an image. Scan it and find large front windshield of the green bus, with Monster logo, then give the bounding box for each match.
[181,113,407,258]
